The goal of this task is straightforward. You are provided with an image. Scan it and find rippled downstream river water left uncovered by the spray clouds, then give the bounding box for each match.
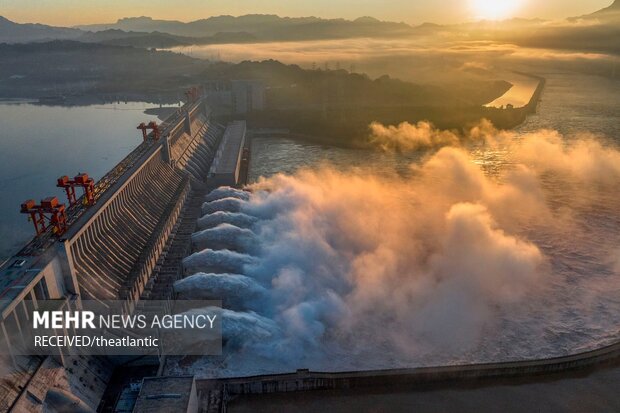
[226,72,620,373]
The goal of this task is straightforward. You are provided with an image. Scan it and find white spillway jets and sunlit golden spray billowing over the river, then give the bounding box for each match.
[169,124,620,376]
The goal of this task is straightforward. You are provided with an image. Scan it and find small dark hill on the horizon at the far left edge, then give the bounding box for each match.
[0,16,82,43]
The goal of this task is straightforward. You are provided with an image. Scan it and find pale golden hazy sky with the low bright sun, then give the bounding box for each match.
[0,0,612,26]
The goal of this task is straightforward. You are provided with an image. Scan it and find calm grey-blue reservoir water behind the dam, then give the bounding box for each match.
[0,102,162,258]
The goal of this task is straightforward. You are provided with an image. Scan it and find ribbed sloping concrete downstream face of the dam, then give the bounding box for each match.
[61,97,219,308]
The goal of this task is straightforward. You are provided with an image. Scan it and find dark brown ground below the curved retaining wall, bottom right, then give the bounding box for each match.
[227,367,620,413]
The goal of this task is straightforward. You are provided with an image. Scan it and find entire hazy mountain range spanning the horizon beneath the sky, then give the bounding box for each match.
[0,8,620,54]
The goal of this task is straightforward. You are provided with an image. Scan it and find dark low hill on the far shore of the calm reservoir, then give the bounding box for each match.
[0,40,208,99]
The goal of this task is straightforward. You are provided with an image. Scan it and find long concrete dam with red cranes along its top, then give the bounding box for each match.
[0,93,247,411]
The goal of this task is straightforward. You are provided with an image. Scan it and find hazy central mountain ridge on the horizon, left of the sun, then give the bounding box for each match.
[77,14,413,40]
